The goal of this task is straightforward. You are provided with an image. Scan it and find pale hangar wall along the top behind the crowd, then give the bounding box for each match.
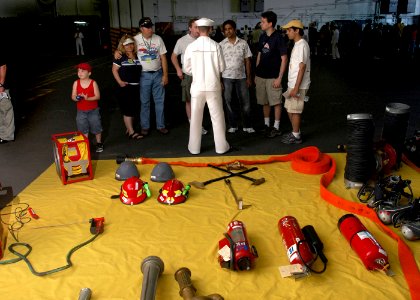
[109,0,420,32]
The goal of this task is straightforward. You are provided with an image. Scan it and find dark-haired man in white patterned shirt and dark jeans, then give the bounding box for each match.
[220,20,255,133]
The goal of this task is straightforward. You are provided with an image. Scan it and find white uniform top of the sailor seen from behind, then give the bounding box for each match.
[184,36,225,95]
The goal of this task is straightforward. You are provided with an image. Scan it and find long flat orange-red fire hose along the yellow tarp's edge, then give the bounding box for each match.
[141,146,420,300]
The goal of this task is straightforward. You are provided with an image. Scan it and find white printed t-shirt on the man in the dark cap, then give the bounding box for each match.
[134,33,167,72]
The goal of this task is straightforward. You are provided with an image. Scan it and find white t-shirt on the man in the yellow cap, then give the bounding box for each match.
[287,38,311,89]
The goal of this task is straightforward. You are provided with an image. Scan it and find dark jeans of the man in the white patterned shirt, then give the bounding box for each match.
[223,78,251,128]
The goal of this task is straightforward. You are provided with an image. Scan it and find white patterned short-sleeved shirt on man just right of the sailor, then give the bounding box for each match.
[220,37,252,79]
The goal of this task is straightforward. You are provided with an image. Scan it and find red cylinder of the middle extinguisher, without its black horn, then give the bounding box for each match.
[278,216,314,266]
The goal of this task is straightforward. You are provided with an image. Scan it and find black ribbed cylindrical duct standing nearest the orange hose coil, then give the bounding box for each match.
[344,114,375,188]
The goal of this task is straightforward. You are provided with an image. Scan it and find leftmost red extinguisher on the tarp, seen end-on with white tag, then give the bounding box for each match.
[218,220,258,271]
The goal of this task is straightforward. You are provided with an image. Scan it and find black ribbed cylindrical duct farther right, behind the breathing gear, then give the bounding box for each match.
[382,103,410,169]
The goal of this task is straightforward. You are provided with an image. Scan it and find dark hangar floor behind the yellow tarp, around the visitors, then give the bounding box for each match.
[0,51,420,197]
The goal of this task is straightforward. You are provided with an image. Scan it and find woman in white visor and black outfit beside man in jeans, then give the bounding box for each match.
[112,34,143,140]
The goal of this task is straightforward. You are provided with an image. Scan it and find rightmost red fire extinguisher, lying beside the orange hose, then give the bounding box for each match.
[338,214,390,275]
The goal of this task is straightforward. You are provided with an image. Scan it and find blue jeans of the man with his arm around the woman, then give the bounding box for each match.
[140,69,165,129]
